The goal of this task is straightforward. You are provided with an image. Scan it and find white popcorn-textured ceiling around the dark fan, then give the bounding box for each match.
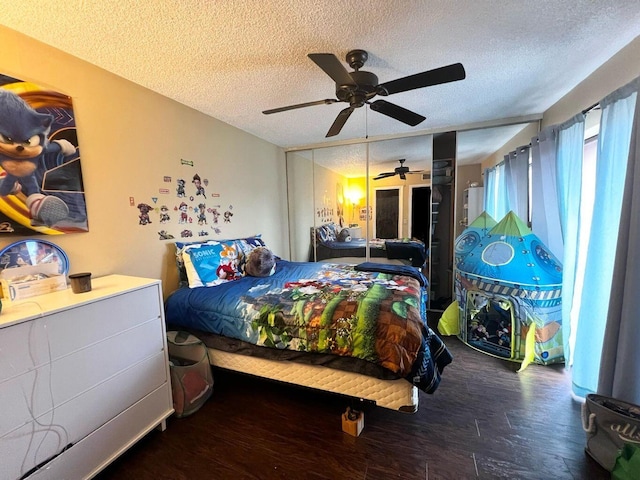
[0,0,640,169]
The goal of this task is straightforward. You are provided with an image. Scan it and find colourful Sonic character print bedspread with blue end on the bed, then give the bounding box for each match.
[165,260,452,393]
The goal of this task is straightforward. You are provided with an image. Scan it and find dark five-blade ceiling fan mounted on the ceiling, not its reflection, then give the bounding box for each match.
[262,50,466,137]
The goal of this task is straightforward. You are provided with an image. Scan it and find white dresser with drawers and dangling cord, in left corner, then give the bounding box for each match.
[0,275,173,480]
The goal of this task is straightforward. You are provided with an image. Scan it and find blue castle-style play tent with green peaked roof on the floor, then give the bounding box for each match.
[455,212,564,368]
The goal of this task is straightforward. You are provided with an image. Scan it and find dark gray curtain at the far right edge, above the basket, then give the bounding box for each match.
[598,84,640,405]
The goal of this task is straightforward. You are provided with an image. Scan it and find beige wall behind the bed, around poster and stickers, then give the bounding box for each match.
[0,27,289,294]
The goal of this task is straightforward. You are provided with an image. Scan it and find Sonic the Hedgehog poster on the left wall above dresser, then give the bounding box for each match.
[0,74,88,235]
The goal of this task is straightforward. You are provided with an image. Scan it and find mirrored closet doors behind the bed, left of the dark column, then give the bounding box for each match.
[287,135,444,308]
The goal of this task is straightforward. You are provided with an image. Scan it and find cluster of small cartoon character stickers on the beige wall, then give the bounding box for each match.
[130,165,234,240]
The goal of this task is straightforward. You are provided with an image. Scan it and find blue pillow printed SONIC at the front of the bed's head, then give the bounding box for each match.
[182,241,242,288]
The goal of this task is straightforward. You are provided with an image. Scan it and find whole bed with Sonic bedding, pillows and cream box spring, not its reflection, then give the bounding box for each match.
[165,237,452,412]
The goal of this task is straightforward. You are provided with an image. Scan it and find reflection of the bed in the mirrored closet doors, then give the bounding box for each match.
[309,223,427,267]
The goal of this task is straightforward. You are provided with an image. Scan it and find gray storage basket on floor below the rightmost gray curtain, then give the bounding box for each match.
[582,393,640,471]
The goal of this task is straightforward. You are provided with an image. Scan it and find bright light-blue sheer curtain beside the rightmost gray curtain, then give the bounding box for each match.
[563,82,638,397]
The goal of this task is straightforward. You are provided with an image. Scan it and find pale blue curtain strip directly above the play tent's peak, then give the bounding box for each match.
[504,145,529,222]
